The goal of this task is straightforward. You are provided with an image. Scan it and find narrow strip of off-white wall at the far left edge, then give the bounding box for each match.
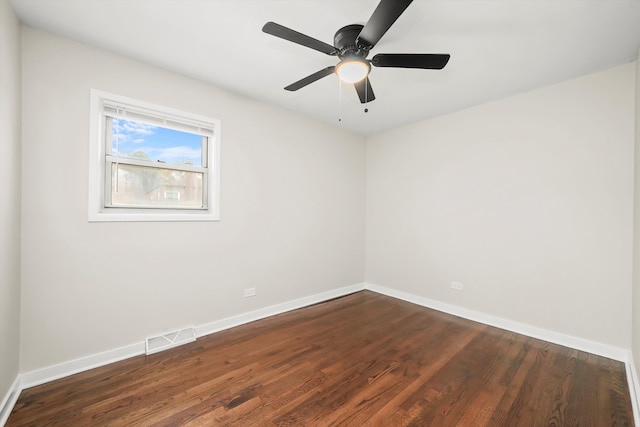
[0,0,20,408]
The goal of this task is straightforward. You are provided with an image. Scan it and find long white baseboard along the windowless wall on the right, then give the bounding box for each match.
[364,283,628,363]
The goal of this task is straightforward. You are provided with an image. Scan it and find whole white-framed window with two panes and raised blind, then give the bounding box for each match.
[89,90,220,221]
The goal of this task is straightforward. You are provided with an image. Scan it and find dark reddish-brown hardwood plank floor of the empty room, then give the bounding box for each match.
[7,291,633,427]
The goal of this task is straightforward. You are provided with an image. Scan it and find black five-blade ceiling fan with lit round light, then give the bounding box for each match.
[262,0,450,104]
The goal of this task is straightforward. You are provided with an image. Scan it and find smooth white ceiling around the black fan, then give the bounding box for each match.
[11,0,640,134]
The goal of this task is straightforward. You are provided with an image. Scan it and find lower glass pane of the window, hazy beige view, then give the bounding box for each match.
[111,163,204,209]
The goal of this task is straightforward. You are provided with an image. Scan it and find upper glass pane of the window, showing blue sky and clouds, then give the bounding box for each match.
[111,118,205,166]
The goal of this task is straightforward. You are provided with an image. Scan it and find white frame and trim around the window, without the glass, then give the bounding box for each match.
[89,89,220,222]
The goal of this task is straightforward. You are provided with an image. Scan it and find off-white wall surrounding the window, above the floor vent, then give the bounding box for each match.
[21,28,365,372]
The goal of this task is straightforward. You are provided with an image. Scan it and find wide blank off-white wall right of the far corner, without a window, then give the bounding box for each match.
[365,64,635,348]
